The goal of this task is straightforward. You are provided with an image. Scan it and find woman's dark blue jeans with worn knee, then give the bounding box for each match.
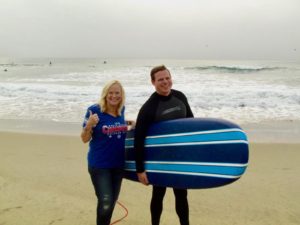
[89,167,123,225]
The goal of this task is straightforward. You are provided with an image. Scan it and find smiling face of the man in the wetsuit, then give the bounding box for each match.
[152,70,173,96]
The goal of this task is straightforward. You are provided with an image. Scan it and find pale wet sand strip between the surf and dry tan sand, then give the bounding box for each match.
[0,119,300,143]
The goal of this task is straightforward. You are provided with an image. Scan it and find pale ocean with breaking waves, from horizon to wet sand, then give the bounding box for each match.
[0,58,300,135]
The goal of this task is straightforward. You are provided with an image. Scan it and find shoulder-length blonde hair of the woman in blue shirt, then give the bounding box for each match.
[99,80,125,116]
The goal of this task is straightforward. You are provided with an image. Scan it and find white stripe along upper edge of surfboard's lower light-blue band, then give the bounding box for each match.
[125,160,248,167]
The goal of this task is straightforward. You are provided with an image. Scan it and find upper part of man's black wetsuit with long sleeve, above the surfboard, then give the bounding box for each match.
[134,90,193,173]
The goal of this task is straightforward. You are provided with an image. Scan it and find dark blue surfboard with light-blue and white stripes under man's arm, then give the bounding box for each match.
[125,118,249,189]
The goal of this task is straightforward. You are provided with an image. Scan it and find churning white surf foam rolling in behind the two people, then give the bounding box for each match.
[0,59,300,123]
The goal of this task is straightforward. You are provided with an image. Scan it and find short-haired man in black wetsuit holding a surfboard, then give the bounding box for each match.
[134,65,193,225]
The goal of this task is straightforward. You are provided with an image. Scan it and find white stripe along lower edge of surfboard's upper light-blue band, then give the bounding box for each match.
[125,140,248,148]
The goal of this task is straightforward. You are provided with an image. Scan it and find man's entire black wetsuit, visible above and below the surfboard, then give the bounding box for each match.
[134,89,193,225]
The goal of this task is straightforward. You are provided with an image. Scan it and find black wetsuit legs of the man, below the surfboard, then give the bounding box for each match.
[150,186,189,225]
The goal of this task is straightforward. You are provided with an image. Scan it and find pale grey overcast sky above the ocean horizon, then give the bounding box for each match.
[0,0,300,60]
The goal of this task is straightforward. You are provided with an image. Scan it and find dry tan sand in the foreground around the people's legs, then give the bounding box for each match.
[0,132,300,225]
